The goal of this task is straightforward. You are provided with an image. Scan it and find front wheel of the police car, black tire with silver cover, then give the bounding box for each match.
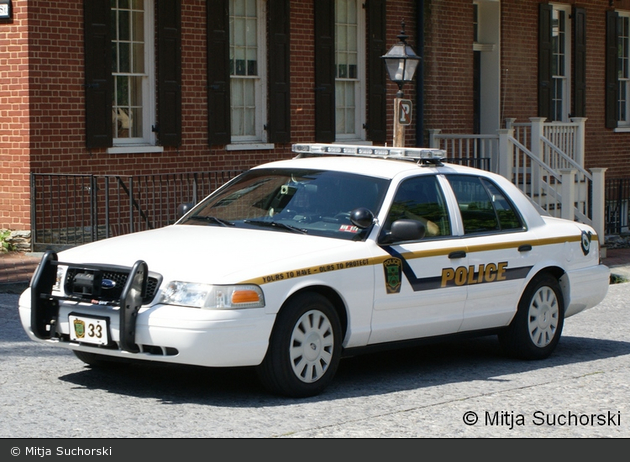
[258,293,341,398]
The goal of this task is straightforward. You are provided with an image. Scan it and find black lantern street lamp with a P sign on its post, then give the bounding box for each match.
[381,20,420,147]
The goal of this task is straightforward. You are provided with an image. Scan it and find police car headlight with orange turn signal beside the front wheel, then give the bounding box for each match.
[160,281,265,310]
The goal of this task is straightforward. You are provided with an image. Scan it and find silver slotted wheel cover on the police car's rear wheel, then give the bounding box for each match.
[527,287,560,348]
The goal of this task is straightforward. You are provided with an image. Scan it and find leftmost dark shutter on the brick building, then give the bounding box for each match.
[83,0,113,148]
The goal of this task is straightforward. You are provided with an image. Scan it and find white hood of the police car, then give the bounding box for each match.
[58,225,357,284]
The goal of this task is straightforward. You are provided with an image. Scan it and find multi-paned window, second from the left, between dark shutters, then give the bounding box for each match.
[229,0,266,143]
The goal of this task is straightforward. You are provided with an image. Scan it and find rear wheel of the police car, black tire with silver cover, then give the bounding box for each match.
[499,273,564,359]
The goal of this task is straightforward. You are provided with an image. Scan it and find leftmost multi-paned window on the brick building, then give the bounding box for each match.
[111,0,155,145]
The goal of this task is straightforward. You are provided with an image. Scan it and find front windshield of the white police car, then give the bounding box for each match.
[179,169,389,240]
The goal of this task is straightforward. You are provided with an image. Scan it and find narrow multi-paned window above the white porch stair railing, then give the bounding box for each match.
[551,6,571,121]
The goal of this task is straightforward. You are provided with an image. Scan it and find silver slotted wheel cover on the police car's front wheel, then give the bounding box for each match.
[289,310,335,383]
